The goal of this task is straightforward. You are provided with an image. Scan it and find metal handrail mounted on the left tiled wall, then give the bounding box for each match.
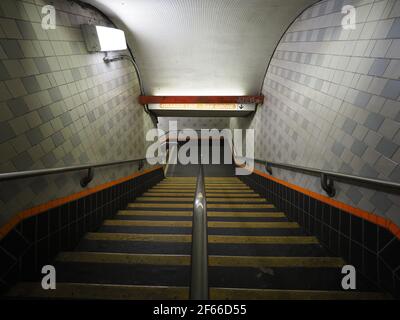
[0,158,146,187]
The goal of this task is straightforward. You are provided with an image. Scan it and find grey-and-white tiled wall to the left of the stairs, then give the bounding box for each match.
[0,0,153,225]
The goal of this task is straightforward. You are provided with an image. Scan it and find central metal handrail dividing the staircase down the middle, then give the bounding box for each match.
[190,165,208,300]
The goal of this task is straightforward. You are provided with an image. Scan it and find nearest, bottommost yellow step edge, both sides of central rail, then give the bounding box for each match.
[7,282,390,300]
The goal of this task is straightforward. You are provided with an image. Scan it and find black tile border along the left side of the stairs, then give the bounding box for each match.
[0,168,164,292]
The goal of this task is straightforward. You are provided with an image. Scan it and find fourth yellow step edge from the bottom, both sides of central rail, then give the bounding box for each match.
[103,220,299,229]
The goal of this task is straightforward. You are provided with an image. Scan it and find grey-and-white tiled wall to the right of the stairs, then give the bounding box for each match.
[231,0,400,225]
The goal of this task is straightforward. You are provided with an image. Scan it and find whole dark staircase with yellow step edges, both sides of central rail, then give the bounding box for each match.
[8,177,385,300]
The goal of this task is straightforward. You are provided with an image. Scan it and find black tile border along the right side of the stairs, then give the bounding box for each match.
[239,173,400,298]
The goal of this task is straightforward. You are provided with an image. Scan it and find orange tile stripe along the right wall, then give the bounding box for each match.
[253,169,400,239]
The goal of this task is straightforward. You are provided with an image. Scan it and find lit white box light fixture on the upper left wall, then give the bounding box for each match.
[81,24,127,52]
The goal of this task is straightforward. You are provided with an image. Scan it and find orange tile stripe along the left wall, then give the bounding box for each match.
[0,166,163,240]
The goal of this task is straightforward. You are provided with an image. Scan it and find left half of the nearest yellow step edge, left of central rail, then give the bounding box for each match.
[7,282,189,300]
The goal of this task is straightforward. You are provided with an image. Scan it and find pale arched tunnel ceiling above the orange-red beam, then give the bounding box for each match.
[85,0,317,95]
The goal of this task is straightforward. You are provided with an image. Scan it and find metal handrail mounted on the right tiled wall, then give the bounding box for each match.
[236,156,400,197]
